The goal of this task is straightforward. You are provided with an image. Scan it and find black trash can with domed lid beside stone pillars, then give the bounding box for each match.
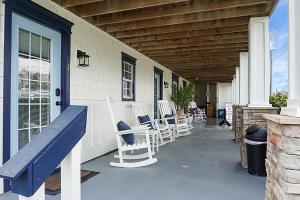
[244,125,267,176]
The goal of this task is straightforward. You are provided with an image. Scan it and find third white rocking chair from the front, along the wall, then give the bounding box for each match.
[158,100,190,137]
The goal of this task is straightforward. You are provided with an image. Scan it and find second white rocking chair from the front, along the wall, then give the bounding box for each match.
[132,104,174,151]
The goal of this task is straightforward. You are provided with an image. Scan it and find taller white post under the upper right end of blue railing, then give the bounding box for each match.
[61,141,81,200]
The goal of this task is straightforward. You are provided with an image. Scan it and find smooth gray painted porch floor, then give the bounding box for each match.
[0,120,266,200]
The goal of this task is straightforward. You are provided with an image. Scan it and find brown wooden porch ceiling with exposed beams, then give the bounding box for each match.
[53,0,278,82]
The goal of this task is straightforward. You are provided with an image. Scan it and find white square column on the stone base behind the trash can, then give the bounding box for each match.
[248,17,272,107]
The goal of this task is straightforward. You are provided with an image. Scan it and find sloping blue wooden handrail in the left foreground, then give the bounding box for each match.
[0,106,87,197]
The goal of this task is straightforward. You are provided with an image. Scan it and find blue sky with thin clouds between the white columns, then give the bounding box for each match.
[270,0,288,92]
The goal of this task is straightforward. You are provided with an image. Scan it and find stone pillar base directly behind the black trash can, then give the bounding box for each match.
[240,107,278,168]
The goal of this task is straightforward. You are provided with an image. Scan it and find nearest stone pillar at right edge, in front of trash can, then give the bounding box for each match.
[265,114,300,200]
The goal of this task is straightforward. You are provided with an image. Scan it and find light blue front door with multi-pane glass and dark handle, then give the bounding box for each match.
[10,13,61,156]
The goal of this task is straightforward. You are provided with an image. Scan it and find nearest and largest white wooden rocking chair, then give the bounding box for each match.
[107,97,157,168]
